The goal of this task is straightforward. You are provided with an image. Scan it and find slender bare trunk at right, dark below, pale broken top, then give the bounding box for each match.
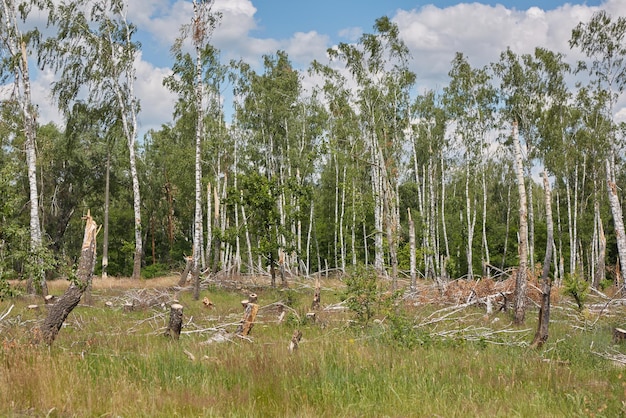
[531,171,554,348]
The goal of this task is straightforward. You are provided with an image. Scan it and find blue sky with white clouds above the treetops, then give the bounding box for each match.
[19,0,626,136]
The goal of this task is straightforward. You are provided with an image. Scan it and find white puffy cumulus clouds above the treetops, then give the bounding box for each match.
[24,0,626,130]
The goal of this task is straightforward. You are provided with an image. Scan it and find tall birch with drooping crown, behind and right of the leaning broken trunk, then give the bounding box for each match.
[42,0,143,279]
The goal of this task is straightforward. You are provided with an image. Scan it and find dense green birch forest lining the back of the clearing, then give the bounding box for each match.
[0,0,626,298]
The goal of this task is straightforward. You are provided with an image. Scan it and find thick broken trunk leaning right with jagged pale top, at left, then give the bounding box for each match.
[37,212,98,345]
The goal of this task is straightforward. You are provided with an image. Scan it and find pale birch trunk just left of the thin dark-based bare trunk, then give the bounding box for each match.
[513,122,528,325]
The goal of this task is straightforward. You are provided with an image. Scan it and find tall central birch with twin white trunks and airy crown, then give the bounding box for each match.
[328,17,415,284]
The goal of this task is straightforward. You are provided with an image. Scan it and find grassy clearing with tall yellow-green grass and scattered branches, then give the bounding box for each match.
[0,277,626,417]
